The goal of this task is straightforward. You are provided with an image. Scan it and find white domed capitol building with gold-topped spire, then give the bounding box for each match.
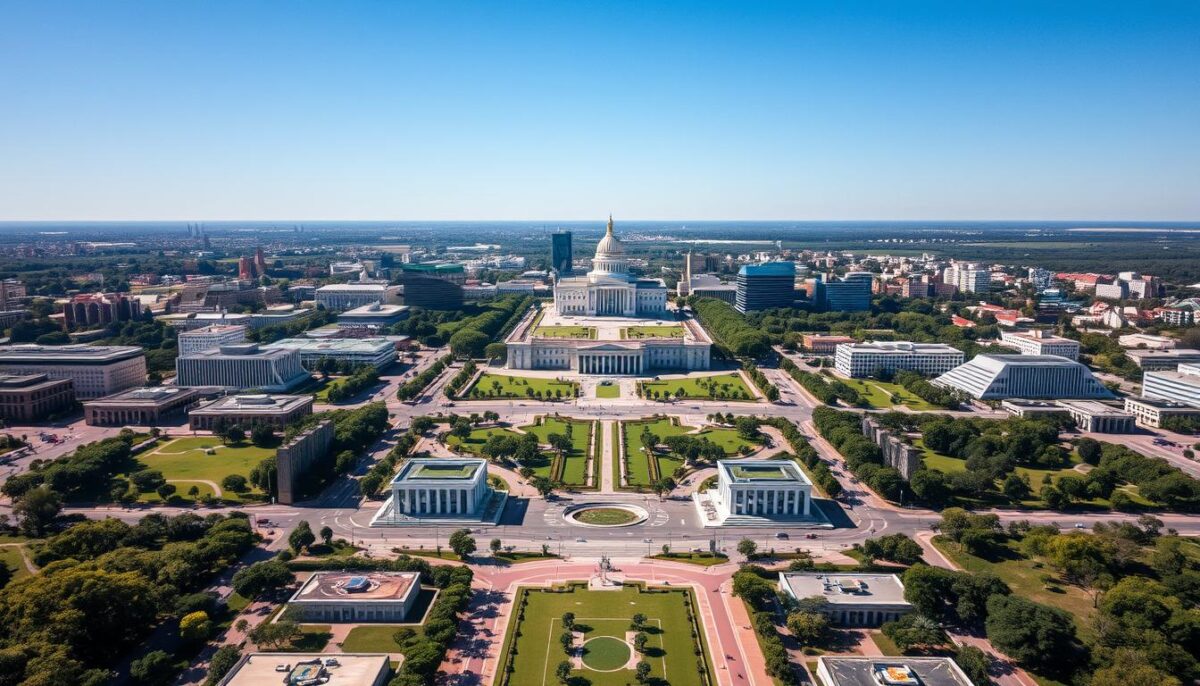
[554,216,667,317]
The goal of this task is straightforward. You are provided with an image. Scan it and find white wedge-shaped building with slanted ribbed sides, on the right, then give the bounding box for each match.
[934,355,1112,401]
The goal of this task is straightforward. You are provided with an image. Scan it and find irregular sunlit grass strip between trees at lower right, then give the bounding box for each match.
[934,536,1096,637]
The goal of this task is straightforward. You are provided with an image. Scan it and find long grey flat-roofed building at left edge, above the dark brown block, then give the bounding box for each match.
[0,343,146,399]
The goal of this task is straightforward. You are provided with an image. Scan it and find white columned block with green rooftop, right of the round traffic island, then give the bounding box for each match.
[714,459,812,524]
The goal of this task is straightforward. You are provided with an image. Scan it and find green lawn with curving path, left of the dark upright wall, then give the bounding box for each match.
[129,437,275,503]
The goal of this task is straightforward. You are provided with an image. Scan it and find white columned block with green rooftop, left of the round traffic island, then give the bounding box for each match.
[391,458,491,518]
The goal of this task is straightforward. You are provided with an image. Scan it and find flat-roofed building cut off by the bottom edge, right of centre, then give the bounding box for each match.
[816,655,976,686]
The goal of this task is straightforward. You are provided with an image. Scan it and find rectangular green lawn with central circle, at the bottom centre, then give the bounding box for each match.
[496,586,715,686]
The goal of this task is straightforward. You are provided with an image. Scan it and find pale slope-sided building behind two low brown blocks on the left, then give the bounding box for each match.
[175,343,312,392]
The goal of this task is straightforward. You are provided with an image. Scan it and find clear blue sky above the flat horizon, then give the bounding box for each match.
[0,0,1200,221]
